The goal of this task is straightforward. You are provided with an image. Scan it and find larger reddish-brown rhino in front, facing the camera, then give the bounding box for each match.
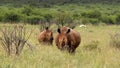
[55,26,81,53]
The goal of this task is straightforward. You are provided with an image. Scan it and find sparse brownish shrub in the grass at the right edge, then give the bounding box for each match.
[109,33,120,48]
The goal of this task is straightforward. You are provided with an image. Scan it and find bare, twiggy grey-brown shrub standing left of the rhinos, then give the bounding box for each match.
[0,25,33,56]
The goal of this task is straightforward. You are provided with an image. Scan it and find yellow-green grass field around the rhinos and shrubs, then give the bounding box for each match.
[0,24,120,68]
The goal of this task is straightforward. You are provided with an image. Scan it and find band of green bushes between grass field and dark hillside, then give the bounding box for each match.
[0,4,120,25]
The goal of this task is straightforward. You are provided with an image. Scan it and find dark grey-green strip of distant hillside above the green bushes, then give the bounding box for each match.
[0,0,120,7]
